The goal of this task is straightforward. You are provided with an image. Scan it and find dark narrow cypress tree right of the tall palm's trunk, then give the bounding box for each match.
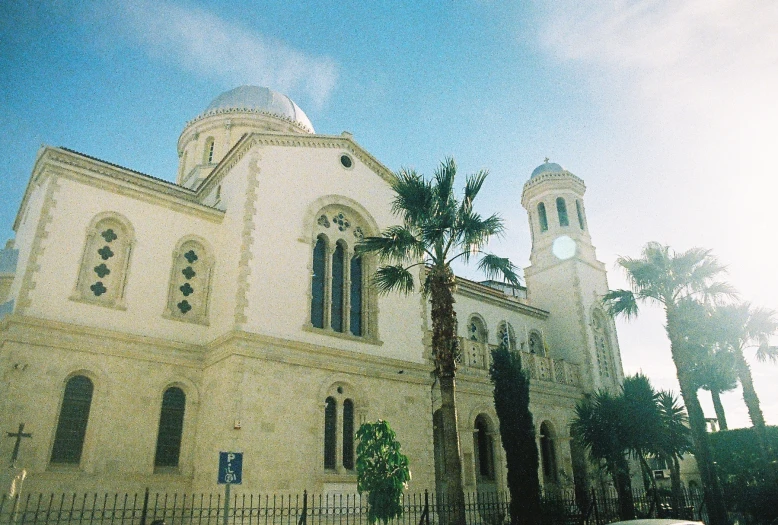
[489,344,540,525]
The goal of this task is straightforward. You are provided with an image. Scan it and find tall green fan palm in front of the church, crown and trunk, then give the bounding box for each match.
[356,158,519,525]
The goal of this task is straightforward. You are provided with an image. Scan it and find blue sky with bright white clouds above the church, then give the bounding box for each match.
[0,0,778,427]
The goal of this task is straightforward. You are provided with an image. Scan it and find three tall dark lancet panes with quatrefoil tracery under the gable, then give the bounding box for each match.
[311,205,375,337]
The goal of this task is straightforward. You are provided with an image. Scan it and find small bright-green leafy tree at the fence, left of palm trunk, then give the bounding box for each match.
[357,419,411,523]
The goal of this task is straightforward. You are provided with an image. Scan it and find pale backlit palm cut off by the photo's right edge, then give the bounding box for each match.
[713,302,778,466]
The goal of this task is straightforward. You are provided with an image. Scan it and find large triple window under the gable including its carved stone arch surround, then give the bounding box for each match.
[300,195,379,341]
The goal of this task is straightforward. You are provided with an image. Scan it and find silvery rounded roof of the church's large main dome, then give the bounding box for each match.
[198,86,315,133]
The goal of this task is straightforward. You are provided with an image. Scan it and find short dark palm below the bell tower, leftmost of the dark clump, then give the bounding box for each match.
[570,390,635,520]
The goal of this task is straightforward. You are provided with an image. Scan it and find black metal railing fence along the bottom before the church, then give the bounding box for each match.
[0,490,707,525]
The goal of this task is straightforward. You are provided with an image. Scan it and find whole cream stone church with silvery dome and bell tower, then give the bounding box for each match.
[0,86,623,494]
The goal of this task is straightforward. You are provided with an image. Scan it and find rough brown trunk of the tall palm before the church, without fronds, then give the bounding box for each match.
[428,268,465,525]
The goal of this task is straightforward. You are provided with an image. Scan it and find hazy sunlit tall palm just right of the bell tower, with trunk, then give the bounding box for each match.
[603,242,734,525]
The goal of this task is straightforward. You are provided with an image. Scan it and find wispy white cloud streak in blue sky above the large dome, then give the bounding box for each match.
[113,0,337,106]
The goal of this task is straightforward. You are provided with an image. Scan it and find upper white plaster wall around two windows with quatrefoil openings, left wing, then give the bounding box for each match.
[22,177,237,343]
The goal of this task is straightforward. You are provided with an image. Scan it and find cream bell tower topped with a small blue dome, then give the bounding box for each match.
[521,159,624,391]
